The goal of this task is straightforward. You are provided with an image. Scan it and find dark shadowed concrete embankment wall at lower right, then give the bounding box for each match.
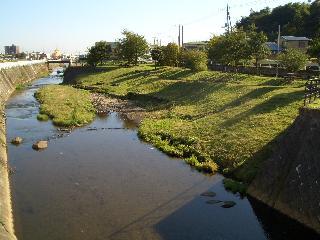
[249,108,320,233]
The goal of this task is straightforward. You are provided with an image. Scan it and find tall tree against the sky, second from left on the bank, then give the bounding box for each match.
[119,30,149,65]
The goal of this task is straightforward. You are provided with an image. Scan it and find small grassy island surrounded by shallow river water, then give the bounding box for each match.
[36,85,95,127]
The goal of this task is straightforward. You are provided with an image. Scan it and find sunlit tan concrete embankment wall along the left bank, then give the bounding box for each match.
[0,64,48,240]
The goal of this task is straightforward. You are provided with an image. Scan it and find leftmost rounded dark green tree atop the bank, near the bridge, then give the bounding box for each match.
[87,41,112,67]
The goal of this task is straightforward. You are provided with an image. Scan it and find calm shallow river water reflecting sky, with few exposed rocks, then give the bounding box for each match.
[6,75,318,240]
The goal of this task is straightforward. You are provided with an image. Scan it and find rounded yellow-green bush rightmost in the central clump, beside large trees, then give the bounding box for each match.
[181,51,208,72]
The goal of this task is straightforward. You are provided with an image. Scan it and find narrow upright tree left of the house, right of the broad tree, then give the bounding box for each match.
[248,30,270,68]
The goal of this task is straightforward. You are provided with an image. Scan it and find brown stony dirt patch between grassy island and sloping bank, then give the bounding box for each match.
[91,93,146,125]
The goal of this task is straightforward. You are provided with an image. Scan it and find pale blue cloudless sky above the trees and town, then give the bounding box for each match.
[0,0,308,54]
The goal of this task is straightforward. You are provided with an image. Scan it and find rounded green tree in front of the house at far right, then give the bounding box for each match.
[278,49,308,72]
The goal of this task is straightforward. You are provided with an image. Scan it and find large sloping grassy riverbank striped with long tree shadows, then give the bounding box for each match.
[65,66,304,182]
